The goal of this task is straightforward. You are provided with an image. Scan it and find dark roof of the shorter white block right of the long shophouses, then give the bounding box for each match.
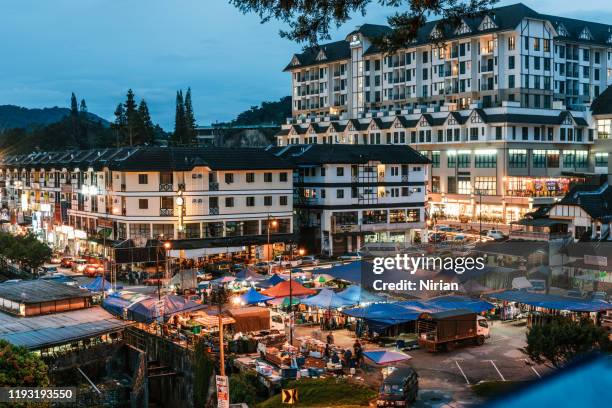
[269,144,429,166]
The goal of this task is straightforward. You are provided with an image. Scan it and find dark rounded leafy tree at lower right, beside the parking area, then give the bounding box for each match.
[524,316,612,367]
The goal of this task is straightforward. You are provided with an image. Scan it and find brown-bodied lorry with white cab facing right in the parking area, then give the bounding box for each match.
[417,309,490,352]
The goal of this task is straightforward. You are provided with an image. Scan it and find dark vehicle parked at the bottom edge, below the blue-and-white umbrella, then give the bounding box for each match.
[376,367,419,407]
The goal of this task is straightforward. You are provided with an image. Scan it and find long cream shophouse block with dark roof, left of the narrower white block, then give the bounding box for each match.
[0,147,294,258]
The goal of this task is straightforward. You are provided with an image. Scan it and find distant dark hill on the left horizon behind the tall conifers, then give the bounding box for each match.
[0,105,108,132]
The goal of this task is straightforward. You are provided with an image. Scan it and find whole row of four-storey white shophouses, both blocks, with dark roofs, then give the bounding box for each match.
[0,145,429,259]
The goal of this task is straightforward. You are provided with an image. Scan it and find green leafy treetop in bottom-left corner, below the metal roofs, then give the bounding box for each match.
[0,340,49,387]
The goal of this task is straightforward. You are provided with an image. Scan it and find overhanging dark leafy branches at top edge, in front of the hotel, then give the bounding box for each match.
[230,0,497,52]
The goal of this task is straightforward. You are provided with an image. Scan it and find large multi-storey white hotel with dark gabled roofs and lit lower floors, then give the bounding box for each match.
[277,3,612,223]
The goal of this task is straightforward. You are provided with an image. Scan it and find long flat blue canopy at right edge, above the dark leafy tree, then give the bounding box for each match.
[488,290,612,312]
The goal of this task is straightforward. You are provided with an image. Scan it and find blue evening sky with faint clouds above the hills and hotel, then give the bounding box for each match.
[0,0,612,130]
